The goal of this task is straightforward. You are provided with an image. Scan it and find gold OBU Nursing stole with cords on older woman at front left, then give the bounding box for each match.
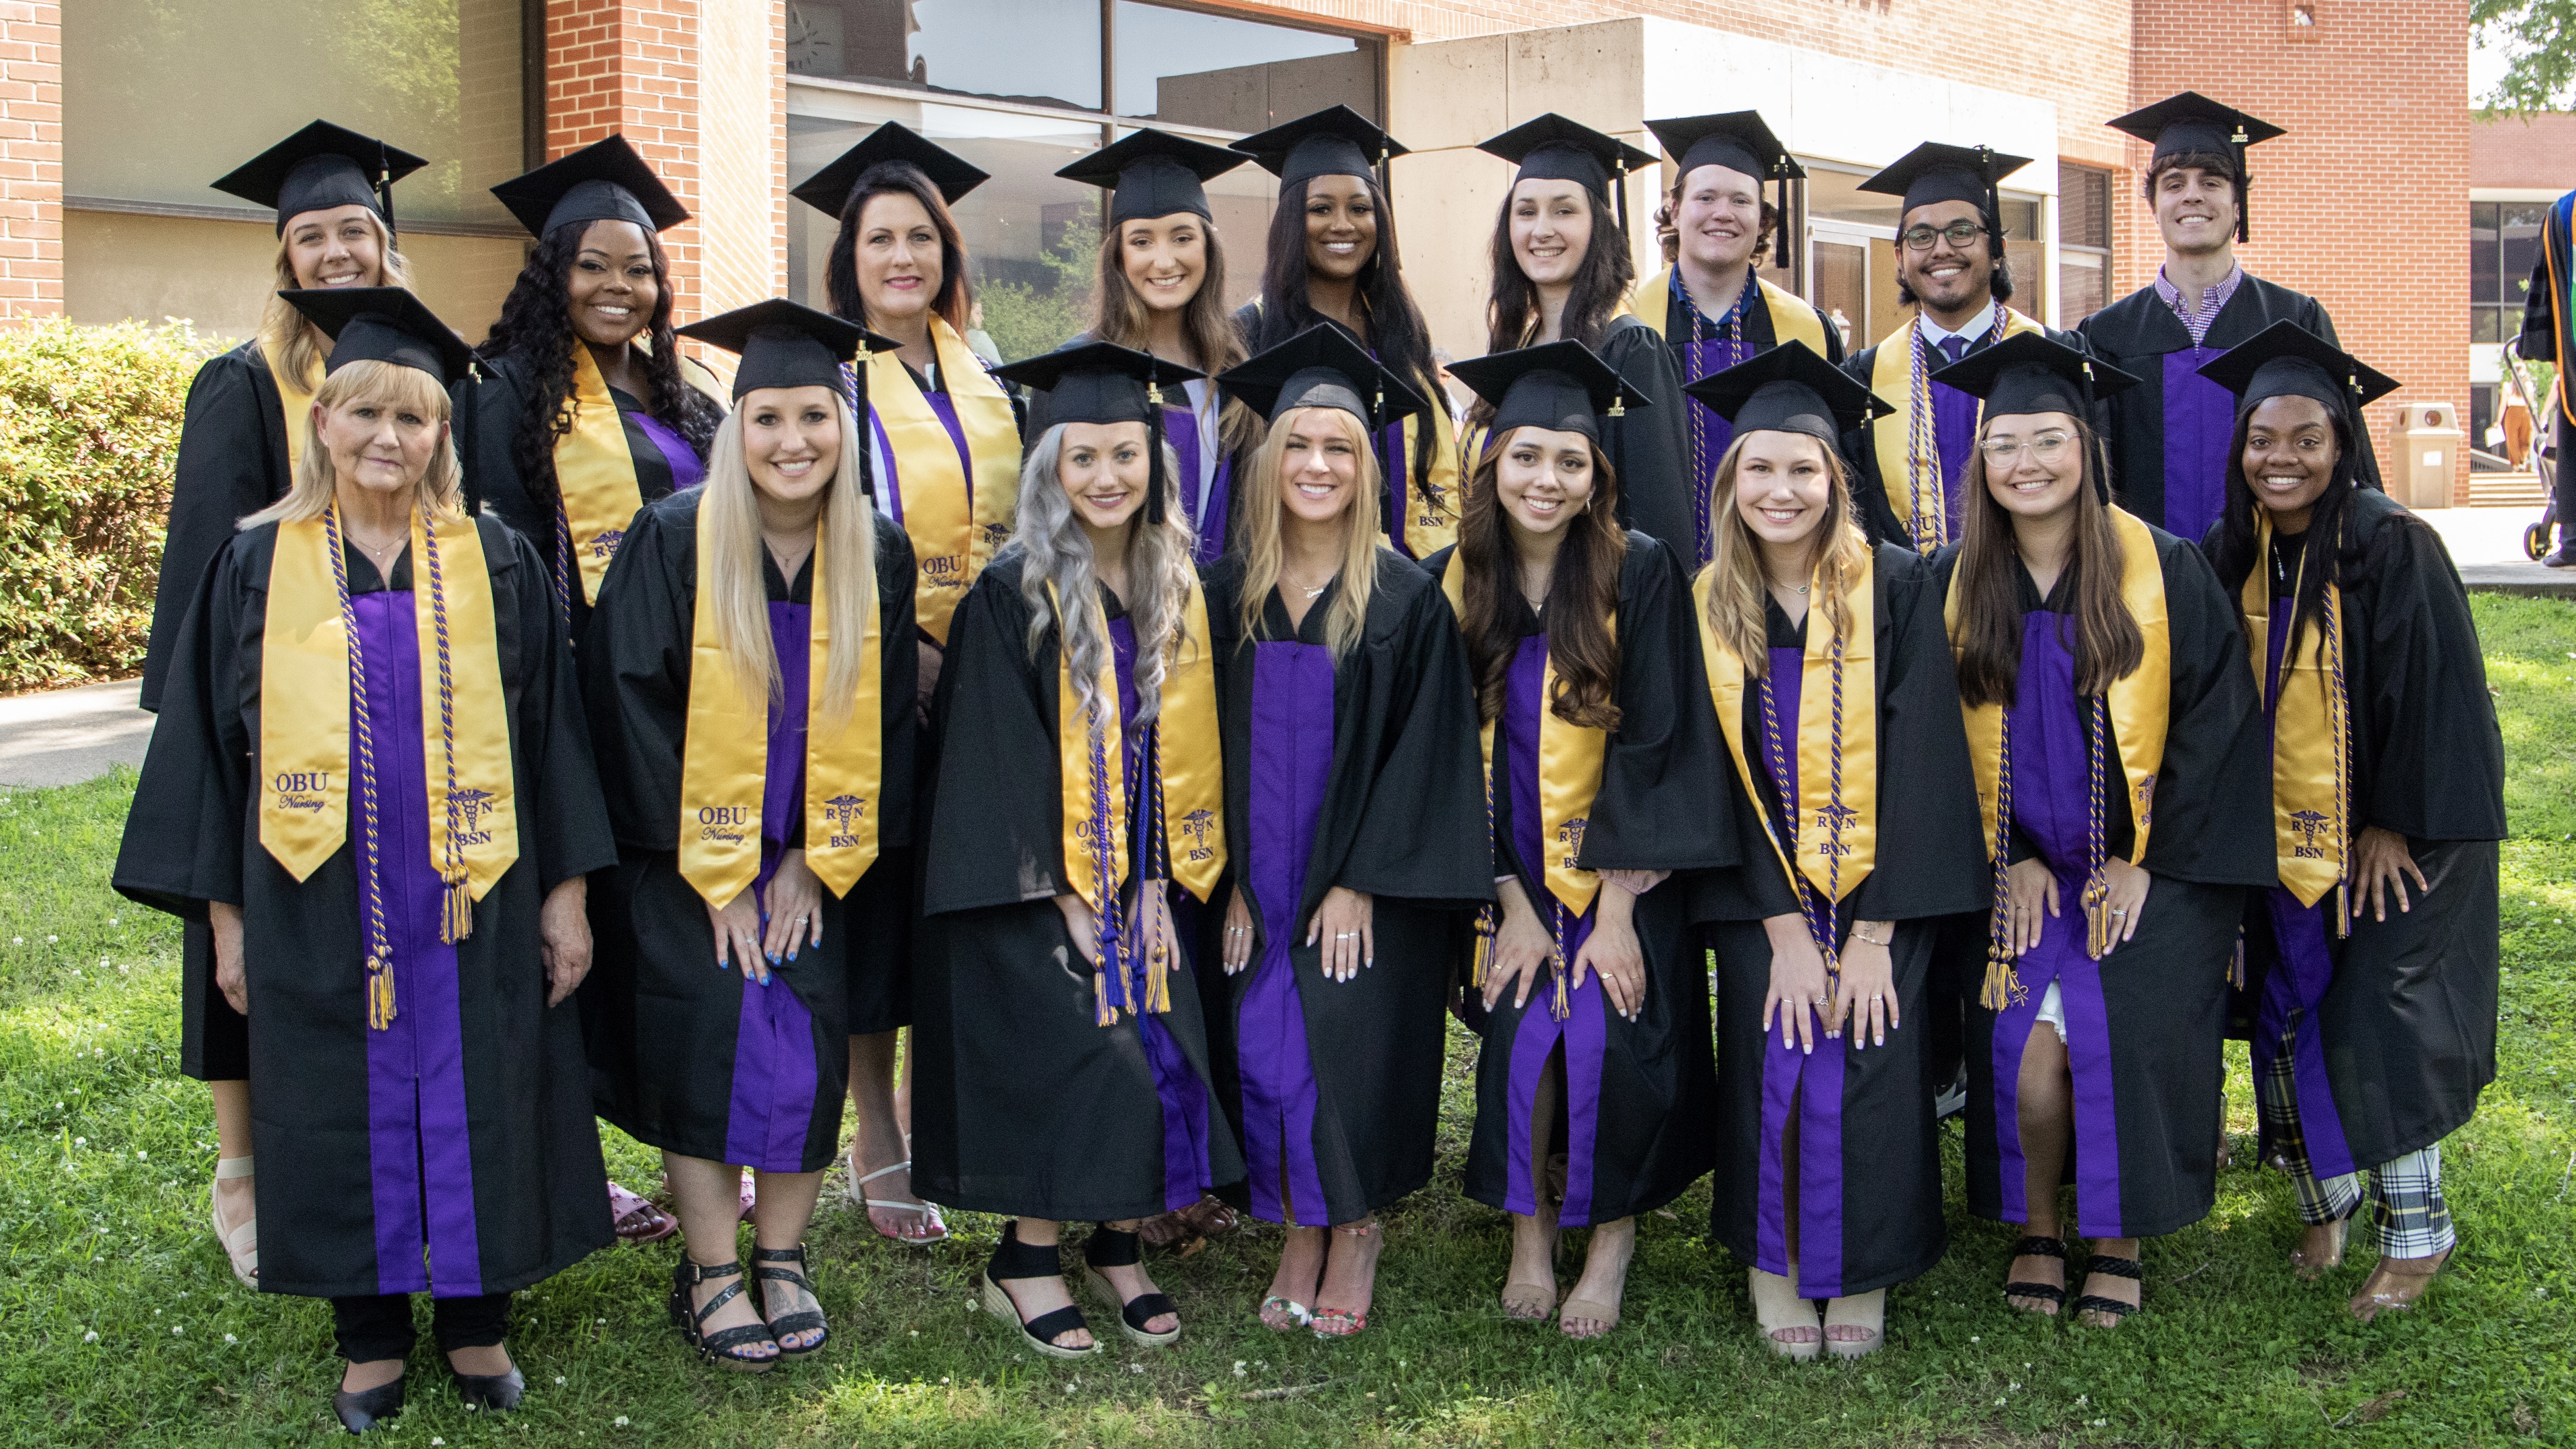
[260,505,518,1029]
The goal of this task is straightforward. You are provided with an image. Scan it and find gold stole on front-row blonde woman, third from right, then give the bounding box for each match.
[1690,559,1878,911]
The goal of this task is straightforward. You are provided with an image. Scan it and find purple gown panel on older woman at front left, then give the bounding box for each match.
[348,590,482,1297]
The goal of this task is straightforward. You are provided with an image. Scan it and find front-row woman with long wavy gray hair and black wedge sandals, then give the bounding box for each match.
[912,342,1244,1359]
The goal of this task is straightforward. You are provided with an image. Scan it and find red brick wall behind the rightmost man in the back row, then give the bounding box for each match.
[2115,0,2462,502]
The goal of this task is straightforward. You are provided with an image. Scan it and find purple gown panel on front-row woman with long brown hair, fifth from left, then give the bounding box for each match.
[1496,633,1610,1227]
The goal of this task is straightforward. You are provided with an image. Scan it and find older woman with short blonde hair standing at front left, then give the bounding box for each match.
[116,288,616,1433]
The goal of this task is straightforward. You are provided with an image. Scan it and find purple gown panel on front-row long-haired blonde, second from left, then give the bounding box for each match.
[724,600,817,1171]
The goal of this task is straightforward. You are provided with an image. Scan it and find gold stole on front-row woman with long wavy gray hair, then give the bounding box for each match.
[1046,576,1226,1027]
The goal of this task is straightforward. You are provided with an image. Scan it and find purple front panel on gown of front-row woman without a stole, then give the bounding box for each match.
[1236,643,1334,1227]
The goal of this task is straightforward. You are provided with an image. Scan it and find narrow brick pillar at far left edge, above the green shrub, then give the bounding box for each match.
[0,0,62,327]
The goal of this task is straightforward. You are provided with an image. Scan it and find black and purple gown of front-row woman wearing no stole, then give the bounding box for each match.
[1200,548,1494,1227]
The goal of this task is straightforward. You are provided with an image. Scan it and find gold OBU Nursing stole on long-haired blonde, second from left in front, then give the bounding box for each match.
[680,507,886,911]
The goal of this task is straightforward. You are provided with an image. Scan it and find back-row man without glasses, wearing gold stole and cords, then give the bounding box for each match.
[1630,110,1842,571]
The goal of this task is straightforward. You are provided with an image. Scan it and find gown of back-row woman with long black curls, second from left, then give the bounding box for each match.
[456,342,721,643]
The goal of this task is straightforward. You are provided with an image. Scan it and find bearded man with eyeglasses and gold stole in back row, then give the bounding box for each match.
[1842,142,2081,554]
